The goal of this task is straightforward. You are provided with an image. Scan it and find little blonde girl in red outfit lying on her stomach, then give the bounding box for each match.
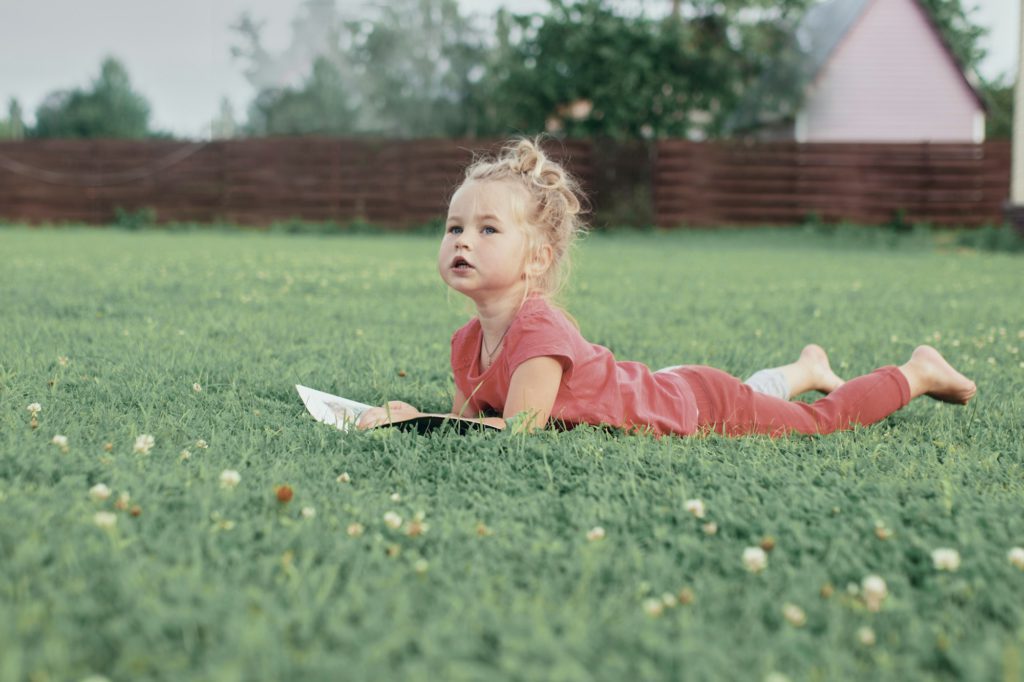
[359,140,976,436]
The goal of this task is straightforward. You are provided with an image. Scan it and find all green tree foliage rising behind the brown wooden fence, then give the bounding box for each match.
[0,0,1013,139]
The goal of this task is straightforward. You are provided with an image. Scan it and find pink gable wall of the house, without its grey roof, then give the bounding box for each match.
[796,0,984,142]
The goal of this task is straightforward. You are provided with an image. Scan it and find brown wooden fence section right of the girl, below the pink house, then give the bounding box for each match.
[653,141,1010,225]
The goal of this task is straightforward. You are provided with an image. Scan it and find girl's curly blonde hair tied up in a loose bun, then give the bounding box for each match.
[463,138,587,298]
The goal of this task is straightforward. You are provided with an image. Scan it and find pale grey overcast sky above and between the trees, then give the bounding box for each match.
[0,0,1024,137]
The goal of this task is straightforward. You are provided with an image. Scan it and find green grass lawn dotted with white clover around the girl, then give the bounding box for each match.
[0,227,1024,682]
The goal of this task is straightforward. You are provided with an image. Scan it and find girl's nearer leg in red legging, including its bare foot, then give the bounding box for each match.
[682,346,976,436]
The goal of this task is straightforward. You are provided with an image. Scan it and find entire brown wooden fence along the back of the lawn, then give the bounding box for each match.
[0,137,1010,227]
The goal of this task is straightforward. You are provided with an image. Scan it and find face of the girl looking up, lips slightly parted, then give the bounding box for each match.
[437,180,530,303]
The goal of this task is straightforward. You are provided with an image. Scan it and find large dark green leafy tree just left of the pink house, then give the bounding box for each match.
[486,0,803,138]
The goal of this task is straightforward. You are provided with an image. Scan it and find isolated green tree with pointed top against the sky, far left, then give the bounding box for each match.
[31,57,151,139]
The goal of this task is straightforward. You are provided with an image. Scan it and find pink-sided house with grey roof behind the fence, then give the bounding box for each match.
[733,0,985,142]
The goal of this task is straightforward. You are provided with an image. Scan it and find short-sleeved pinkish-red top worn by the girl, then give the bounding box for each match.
[452,297,697,435]
